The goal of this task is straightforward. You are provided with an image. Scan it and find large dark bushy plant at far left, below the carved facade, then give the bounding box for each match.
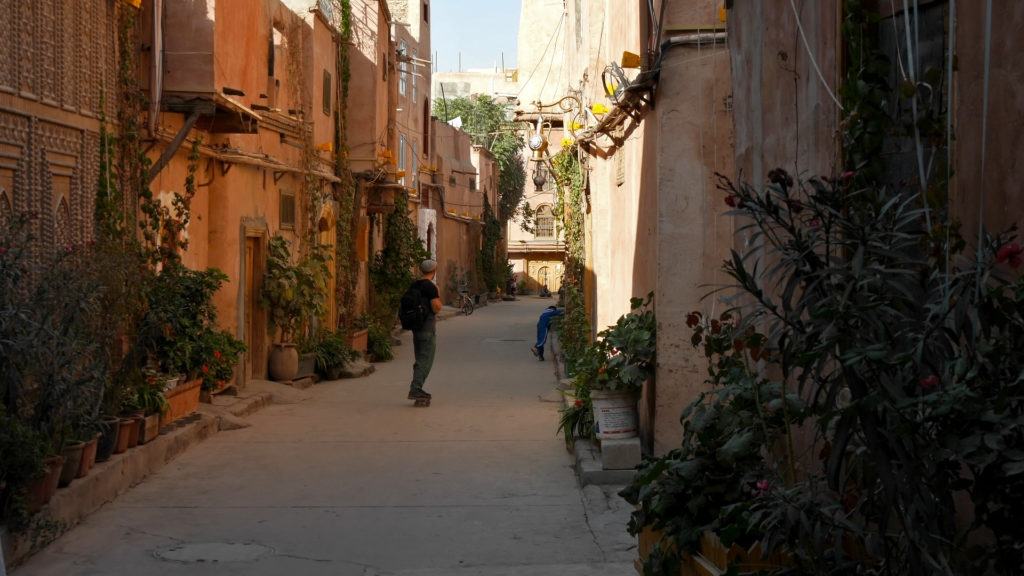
[0,216,109,510]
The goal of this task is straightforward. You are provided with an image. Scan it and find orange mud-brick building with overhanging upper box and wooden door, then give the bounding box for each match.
[138,0,350,382]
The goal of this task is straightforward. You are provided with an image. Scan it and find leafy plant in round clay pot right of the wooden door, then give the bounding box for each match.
[260,235,330,381]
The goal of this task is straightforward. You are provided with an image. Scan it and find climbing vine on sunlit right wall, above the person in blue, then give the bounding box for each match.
[552,148,590,374]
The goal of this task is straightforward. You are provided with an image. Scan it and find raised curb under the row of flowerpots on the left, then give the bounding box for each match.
[0,393,272,575]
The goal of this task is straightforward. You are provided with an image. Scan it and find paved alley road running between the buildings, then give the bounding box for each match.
[13,296,635,576]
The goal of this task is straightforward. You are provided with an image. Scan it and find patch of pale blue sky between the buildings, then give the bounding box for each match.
[430,0,520,72]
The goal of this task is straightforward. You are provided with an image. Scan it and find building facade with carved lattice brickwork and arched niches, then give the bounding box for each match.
[0,0,117,250]
